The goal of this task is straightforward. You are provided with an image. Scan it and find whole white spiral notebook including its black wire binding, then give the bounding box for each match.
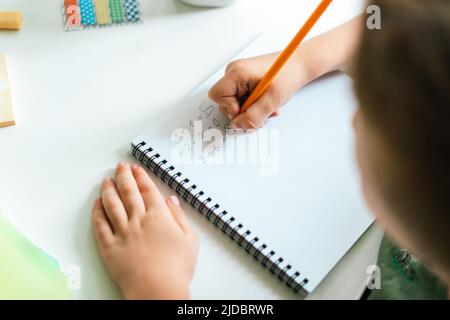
[131,35,373,296]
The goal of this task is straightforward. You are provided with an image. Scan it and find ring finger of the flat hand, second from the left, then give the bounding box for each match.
[101,179,128,233]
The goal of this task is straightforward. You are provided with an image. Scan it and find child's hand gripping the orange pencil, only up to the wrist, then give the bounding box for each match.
[209,53,308,129]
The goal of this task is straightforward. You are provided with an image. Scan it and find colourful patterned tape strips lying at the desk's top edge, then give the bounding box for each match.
[64,0,141,30]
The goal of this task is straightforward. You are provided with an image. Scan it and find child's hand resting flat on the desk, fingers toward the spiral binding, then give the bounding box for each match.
[92,163,197,299]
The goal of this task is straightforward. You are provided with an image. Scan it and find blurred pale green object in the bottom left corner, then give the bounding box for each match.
[0,214,71,300]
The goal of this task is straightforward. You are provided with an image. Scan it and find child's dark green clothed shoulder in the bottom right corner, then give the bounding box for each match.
[369,236,448,300]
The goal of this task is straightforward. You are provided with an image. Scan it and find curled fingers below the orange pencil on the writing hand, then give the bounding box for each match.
[230,88,279,130]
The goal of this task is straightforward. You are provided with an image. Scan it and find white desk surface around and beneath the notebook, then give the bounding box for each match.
[0,0,380,299]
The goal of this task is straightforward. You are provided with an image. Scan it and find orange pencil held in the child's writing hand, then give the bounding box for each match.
[241,0,333,112]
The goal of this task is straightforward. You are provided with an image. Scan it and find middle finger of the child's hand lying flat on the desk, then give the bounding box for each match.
[116,162,145,219]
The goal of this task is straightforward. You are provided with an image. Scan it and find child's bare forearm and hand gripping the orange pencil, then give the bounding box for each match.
[209,16,362,129]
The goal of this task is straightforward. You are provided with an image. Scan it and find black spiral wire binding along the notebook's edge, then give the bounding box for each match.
[131,141,308,296]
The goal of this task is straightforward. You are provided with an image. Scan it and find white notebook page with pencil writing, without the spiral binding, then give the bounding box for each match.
[134,35,373,292]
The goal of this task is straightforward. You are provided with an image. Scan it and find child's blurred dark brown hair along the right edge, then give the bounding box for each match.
[354,0,450,278]
